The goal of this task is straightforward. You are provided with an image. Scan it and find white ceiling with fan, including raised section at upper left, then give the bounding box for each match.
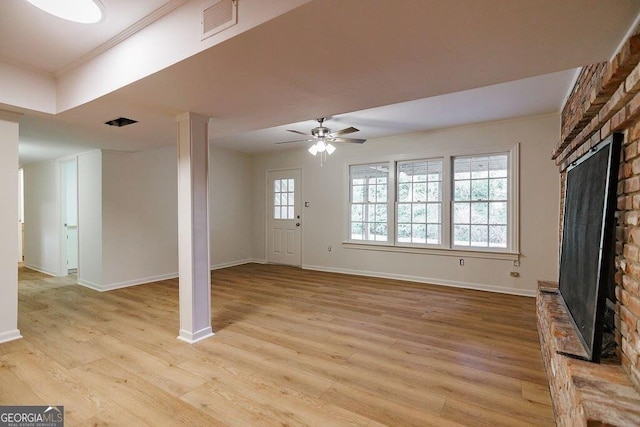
[0,0,640,163]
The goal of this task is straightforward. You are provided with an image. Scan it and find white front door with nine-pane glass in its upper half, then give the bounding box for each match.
[267,169,302,266]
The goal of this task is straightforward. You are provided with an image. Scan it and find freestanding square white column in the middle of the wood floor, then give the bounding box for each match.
[177,112,213,343]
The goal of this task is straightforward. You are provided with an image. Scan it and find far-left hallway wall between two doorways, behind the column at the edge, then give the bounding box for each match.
[24,160,62,276]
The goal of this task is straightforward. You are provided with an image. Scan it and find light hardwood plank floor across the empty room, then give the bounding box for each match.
[0,264,553,426]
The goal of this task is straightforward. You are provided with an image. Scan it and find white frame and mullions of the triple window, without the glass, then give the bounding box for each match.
[343,143,520,261]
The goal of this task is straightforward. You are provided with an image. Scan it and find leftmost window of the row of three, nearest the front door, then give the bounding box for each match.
[349,163,389,242]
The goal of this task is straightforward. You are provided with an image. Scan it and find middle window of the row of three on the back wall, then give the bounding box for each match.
[396,160,442,245]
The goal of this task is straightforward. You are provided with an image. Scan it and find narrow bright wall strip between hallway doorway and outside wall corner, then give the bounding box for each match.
[78,151,102,288]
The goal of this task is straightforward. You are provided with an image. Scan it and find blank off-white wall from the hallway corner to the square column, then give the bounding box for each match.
[102,147,178,289]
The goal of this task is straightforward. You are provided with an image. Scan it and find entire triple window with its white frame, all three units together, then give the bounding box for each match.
[348,146,518,259]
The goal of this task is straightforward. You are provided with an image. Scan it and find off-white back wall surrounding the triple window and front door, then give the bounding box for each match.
[252,115,560,295]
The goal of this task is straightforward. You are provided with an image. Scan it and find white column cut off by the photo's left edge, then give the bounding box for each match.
[0,110,22,343]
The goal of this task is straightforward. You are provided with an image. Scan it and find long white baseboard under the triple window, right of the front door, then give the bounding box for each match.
[302,265,536,297]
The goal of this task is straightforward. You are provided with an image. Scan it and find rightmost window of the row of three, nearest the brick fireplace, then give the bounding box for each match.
[453,154,508,249]
